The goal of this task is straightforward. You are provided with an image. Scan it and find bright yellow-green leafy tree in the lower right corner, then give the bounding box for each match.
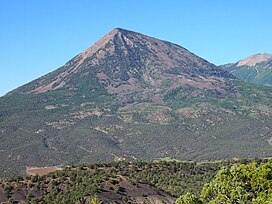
[201,162,272,204]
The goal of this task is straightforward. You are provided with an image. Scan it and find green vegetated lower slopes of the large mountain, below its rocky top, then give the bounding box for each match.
[0,78,272,177]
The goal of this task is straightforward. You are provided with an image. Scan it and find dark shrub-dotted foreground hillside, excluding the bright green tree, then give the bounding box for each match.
[0,161,215,204]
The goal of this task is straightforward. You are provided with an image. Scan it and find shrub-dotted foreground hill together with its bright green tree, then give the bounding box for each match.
[0,159,272,204]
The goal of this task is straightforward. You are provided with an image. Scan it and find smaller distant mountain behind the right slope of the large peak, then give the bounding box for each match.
[220,53,272,86]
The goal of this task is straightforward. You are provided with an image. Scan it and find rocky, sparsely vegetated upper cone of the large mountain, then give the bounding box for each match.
[13,28,234,102]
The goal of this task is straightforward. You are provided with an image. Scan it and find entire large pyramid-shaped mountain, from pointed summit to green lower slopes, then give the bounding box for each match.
[0,28,272,176]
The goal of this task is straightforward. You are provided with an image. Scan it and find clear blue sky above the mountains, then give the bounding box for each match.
[0,0,272,95]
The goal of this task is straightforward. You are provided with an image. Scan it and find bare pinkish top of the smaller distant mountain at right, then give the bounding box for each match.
[237,53,272,67]
